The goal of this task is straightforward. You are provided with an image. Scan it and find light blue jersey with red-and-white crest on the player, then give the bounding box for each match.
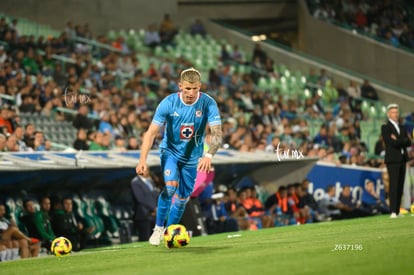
[152,92,221,165]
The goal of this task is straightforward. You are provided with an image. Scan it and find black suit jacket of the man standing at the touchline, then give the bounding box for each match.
[381,120,411,163]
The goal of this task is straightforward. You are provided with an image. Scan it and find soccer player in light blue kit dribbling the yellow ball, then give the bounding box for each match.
[136,68,222,246]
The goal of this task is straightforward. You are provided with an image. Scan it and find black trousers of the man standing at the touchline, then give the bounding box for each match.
[387,163,406,215]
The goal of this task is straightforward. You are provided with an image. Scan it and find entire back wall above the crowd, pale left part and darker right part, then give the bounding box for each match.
[0,0,297,34]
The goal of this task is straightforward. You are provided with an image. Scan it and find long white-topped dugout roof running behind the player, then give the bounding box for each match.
[0,150,317,194]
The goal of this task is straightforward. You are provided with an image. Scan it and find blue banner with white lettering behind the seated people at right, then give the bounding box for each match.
[307,162,385,201]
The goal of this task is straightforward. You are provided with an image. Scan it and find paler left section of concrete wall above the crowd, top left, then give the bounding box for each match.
[0,0,177,34]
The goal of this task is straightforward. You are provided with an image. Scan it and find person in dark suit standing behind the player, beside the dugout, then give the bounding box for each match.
[131,171,159,242]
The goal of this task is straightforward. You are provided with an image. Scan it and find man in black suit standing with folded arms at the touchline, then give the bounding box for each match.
[381,104,411,218]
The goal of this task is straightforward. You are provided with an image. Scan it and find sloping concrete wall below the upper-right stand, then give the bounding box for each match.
[299,0,414,95]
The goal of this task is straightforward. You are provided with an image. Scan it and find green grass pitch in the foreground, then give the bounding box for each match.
[0,217,414,275]
